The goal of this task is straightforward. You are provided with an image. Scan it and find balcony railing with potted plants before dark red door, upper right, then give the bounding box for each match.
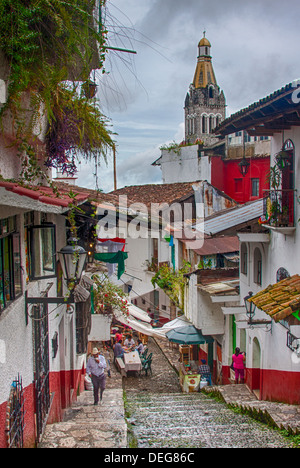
[264,189,296,227]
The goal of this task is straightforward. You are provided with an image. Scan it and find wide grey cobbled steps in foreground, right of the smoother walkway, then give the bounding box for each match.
[126,392,290,448]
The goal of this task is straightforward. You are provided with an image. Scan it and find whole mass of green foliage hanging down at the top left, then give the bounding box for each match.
[0,0,114,180]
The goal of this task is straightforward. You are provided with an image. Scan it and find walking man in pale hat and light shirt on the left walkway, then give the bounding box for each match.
[86,348,107,405]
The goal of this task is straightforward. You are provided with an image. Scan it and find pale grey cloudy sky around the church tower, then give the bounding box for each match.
[77,0,300,192]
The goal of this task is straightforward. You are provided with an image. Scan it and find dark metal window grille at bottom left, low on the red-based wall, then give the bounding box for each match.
[6,375,25,448]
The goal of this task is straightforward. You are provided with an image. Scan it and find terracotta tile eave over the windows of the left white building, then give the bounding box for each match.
[0,180,89,208]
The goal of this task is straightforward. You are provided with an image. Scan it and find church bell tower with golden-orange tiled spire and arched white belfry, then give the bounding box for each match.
[184,32,226,145]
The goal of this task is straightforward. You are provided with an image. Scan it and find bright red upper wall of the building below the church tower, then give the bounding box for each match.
[211,156,270,203]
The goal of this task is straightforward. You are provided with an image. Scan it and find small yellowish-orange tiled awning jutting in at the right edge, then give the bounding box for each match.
[249,275,300,322]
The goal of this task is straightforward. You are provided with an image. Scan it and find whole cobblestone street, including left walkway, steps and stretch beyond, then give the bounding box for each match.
[39,340,298,448]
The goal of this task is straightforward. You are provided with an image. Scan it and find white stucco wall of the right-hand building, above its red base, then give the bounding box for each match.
[240,127,300,372]
